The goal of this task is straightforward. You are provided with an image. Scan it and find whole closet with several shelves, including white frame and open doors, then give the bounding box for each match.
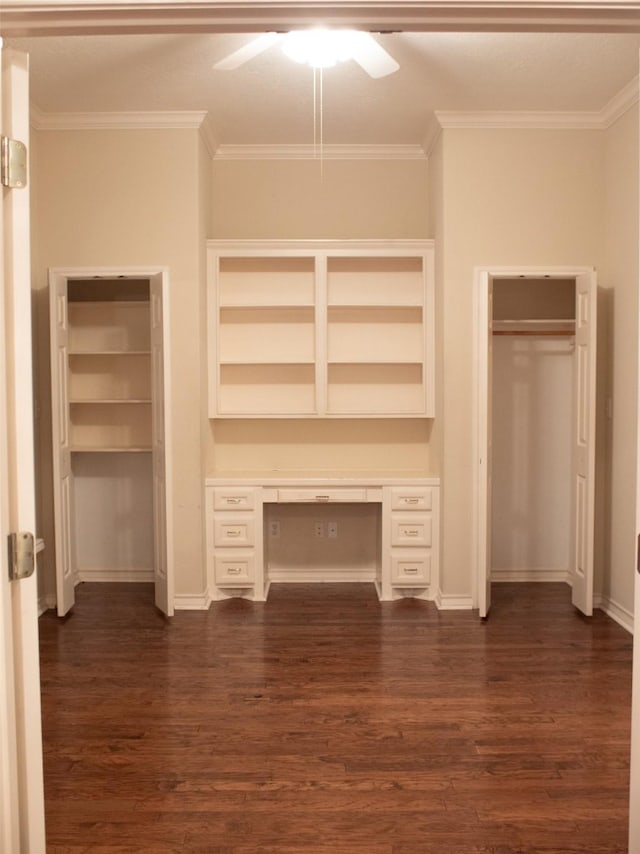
[50,270,173,616]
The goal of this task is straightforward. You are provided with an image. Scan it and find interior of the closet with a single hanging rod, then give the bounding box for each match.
[490,278,576,583]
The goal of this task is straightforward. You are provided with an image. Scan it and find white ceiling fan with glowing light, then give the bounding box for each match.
[213,29,400,78]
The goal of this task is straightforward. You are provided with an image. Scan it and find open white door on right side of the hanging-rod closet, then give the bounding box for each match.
[571,273,597,616]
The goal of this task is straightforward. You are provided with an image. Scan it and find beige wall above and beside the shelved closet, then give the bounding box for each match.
[32,130,206,594]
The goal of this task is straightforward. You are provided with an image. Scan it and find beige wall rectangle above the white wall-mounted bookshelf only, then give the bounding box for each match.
[211,160,428,240]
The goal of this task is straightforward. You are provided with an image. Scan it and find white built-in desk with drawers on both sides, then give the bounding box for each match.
[205,472,440,601]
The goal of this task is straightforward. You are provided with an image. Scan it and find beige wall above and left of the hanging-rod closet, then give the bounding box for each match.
[439,129,604,596]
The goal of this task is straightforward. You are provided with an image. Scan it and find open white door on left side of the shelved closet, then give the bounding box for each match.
[49,273,76,617]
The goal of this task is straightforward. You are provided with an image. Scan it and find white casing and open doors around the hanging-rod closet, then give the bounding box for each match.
[474,267,597,617]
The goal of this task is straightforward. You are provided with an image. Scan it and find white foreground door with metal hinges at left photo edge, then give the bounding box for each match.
[0,40,45,854]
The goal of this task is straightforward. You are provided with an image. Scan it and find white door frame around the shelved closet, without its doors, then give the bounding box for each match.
[49,266,175,617]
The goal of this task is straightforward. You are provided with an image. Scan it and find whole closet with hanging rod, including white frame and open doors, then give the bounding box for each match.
[474,268,597,618]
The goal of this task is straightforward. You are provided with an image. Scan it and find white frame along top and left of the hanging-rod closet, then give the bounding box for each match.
[472,265,594,617]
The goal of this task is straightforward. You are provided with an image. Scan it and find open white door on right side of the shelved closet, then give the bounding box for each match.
[150,273,174,617]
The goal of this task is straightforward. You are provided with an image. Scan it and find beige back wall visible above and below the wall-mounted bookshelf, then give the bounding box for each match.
[207,160,437,474]
